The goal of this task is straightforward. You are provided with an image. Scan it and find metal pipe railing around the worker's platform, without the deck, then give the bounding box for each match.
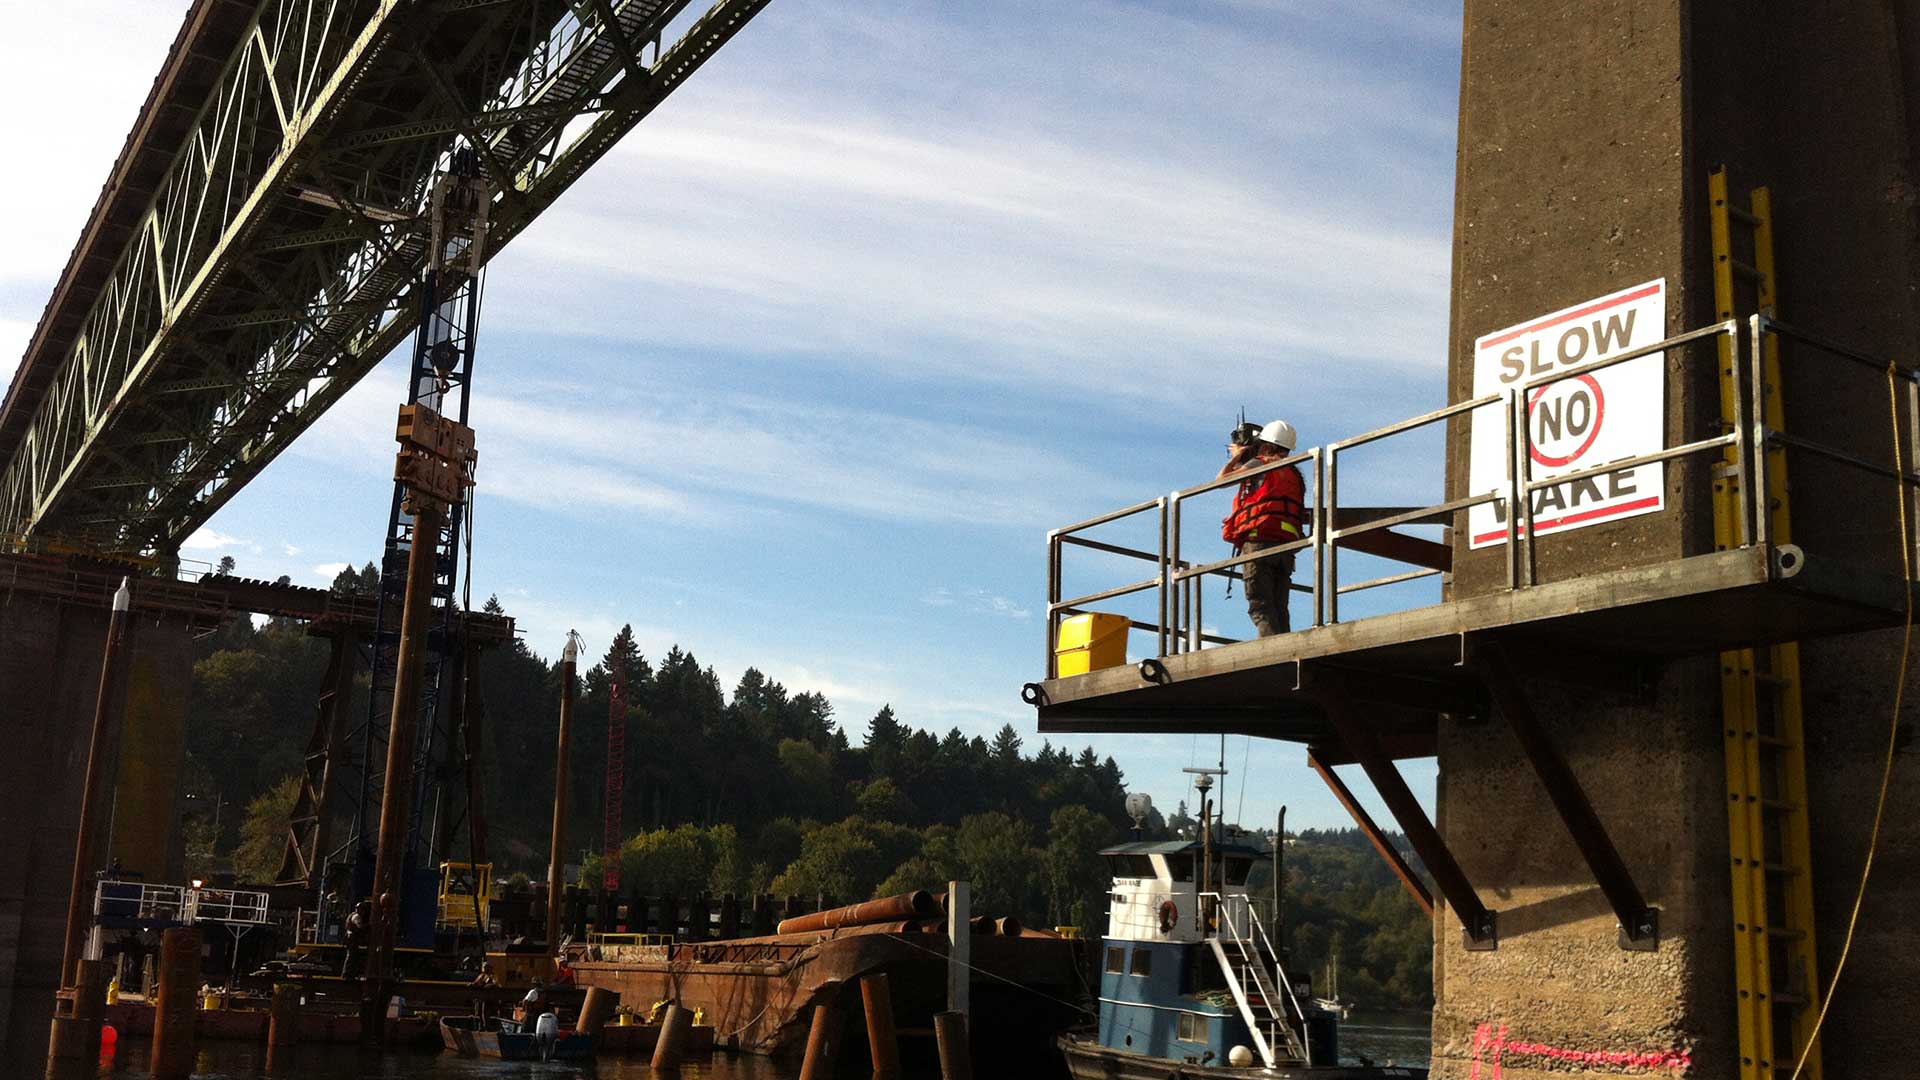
[1044,315,1920,678]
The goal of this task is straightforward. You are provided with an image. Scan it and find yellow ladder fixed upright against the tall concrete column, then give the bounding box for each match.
[1707,167,1820,1080]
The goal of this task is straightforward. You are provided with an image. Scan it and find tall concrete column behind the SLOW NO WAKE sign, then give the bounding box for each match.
[1434,0,1920,1080]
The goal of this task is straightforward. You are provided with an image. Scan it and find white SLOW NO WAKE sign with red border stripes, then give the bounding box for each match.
[1467,279,1667,548]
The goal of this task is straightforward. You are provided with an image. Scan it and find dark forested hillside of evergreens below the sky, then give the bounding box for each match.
[184,567,1430,1005]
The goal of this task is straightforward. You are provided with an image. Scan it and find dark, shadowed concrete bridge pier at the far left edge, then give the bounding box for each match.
[0,580,192,1065]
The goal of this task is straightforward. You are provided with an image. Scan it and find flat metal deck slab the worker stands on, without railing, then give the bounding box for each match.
[1039,546,1907,745]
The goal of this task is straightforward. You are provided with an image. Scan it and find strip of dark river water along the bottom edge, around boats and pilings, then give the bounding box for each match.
[37,1013,1430,1080]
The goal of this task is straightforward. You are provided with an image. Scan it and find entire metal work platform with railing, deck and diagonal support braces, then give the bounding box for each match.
[1021,315,1920,949]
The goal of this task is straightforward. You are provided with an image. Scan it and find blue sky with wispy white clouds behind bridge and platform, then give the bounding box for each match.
[0,0,1459,824]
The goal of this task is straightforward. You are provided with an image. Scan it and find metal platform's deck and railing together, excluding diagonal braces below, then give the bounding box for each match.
[1023,317,1920,757]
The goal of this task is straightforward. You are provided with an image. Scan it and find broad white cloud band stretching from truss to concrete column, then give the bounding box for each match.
[499,102,1446,394]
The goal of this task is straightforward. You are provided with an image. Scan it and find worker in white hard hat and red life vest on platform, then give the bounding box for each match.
[1219,411,1308,638]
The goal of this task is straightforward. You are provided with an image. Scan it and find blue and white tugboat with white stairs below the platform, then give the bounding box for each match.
[1056,769,1427,1080]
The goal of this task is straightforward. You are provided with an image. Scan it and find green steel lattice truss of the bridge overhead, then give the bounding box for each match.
[0,0,768,555]
